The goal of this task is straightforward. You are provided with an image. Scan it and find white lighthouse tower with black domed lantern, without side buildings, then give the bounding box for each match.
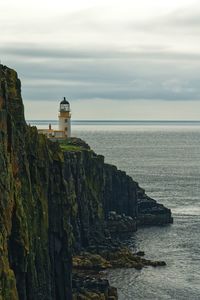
[58,97,71,137]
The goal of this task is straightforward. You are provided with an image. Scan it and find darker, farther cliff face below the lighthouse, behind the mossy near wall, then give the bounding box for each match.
[64,150,137,250]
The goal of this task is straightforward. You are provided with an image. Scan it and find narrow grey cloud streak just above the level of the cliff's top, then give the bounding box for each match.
[0,44,200,63]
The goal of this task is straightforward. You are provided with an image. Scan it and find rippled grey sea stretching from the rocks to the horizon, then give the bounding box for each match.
[27,120,200,300]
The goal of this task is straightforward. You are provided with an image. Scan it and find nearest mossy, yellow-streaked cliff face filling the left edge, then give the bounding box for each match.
[0,66,72,300]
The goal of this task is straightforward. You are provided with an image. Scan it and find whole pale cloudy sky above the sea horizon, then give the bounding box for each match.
[0,0,200,120]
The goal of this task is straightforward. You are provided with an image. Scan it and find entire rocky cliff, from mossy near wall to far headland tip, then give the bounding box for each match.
[0,65,171,300]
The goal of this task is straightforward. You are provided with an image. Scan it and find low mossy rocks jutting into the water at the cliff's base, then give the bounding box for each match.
[72,247,166,300]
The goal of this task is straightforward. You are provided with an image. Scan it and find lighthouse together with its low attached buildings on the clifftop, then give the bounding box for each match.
[38,97,71,140]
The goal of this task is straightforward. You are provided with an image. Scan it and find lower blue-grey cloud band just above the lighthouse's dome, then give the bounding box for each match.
[20,64,200,101]
